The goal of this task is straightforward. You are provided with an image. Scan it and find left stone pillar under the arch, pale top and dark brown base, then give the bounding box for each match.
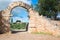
[0,11,10,34]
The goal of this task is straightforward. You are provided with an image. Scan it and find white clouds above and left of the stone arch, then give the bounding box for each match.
[0,0,31,10]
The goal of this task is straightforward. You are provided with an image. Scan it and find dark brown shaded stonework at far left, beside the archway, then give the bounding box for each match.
[0,11,10,34]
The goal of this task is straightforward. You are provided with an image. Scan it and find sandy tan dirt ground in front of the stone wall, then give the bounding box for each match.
[0,32,60,40]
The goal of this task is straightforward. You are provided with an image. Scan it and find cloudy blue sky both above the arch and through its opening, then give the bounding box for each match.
[0,0,38,22]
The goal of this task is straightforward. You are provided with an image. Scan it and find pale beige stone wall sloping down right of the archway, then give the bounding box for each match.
[28,10,60,35]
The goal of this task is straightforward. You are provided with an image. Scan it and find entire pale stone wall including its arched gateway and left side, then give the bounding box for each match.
[0,2,60,35]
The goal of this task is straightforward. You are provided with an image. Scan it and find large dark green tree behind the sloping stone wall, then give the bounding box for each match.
[36,0,60,18]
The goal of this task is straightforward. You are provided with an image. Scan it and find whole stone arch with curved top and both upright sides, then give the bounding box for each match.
[2,1,38,32]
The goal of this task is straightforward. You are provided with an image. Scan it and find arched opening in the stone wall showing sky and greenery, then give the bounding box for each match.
[10,6,29,32]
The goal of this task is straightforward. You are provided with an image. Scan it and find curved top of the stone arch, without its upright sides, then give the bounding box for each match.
[7,1,32,11]
